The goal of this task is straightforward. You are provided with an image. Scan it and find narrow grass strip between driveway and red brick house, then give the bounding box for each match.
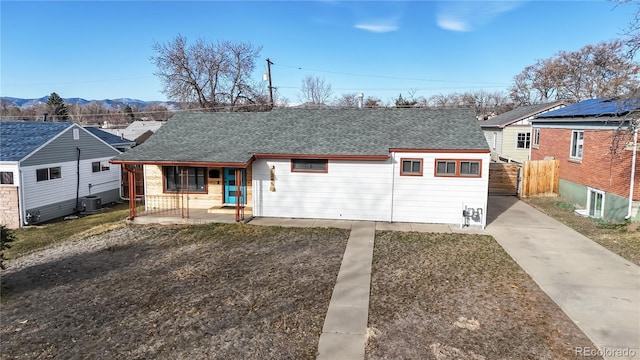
[523,197,640,265]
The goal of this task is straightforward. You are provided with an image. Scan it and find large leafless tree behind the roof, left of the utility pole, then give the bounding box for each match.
[151,35,262,111]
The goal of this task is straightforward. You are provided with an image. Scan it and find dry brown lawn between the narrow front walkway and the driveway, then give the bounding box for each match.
[366,232,595,360]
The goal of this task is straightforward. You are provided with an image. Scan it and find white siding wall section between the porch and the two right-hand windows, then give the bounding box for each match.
[253,159,391,221]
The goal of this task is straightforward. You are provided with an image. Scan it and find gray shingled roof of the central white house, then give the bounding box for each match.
[114,109,489,164]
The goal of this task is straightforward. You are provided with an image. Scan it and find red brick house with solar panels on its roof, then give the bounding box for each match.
[531,99,640,221]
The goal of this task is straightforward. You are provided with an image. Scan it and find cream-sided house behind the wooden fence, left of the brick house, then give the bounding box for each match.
[480,101,566,162]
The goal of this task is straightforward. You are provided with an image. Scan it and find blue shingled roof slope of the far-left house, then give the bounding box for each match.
[0,121,73,161]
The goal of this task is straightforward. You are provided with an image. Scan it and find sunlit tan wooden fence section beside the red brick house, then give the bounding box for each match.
[520,160,560,197]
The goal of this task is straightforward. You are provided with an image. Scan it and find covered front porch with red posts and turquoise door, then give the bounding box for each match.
[116,163,252,224]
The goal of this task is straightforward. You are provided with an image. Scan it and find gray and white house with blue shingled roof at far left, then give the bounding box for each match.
[0,121,120,228]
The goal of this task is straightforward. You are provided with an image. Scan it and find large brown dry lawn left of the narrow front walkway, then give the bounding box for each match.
[0,224,349,359]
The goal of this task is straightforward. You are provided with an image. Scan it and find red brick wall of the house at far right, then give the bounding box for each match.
[531,128,640,200]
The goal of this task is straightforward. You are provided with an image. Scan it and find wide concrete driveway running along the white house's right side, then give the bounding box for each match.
[487,196,640,359]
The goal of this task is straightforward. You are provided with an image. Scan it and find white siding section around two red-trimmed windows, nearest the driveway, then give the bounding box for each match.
[393,153,490,225]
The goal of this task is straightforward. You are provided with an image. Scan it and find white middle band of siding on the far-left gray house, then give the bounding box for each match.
[22,156,120,209]
